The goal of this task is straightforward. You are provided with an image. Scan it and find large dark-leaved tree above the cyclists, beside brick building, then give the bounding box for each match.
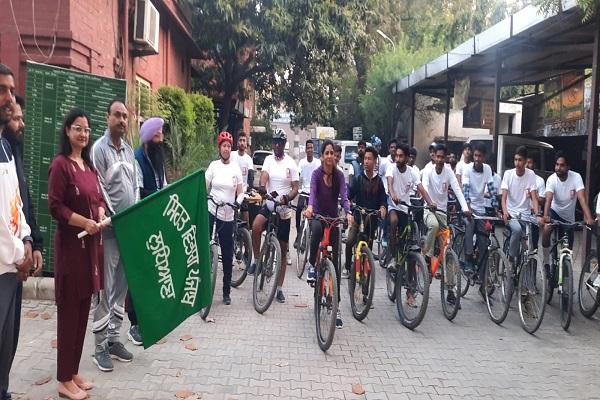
[193,0,366,129]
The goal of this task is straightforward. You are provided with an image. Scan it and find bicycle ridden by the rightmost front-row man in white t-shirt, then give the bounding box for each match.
[546,220,586,330]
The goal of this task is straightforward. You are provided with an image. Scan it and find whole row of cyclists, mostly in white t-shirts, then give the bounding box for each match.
[206,128,600,328]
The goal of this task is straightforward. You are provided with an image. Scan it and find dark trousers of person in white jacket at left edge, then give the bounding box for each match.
[0,272,19,393]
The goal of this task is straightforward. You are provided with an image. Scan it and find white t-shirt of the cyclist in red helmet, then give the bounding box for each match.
[204,160,242,221]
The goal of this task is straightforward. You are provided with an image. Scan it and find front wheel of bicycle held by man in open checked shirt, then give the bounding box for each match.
[482,249,512,325]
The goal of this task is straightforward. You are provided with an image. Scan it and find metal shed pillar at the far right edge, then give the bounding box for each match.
[584,23,600,254]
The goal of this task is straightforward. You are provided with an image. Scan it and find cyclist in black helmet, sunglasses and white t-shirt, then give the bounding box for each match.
[248,128,299,303]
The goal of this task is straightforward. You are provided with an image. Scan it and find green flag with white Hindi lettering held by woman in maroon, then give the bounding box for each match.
[112,170,212,348]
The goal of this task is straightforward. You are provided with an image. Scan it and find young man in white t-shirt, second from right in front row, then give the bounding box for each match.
[500,146,543,263]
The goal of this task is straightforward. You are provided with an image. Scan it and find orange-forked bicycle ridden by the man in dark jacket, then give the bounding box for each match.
[339,206,379,321]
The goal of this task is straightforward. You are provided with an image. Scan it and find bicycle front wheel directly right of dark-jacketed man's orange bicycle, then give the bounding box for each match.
[395,252,429,330]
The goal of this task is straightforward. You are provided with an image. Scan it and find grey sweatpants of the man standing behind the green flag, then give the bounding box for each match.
[92,228,127,351]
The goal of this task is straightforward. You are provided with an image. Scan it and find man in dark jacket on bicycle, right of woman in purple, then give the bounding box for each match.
[342,147,387,278]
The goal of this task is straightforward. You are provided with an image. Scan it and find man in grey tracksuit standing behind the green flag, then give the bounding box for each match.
[92,101,139,372]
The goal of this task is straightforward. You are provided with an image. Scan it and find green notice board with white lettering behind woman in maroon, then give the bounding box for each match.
[24,62,127,272]
